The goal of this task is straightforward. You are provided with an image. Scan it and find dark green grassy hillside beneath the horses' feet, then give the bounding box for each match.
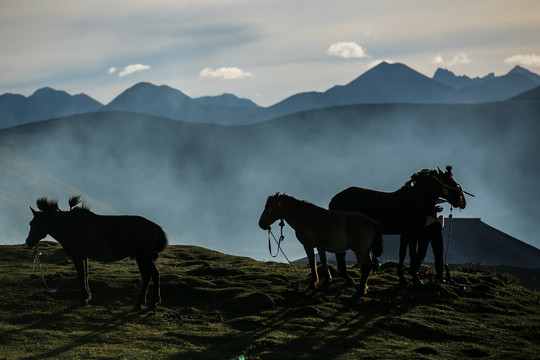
[0,242,540,359]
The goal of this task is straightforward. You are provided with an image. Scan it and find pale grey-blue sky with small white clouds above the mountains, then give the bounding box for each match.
[0,0,540,106]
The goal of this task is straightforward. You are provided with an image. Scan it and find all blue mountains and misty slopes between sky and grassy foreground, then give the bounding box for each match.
[0,63,540,261]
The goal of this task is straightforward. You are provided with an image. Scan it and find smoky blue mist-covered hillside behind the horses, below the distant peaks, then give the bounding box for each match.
[0,103,540,261]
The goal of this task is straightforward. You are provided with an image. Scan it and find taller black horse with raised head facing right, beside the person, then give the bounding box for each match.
[329,166,466,282]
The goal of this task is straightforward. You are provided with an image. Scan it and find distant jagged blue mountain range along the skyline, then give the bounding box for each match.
[0,62,540,128]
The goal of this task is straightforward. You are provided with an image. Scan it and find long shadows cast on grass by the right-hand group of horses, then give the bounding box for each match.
[162,264,458,359]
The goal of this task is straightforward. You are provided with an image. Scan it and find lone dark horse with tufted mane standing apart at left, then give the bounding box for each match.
[26,196,167,309]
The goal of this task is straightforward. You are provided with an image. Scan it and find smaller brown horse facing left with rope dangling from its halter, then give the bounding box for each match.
[259,193,382,294]
